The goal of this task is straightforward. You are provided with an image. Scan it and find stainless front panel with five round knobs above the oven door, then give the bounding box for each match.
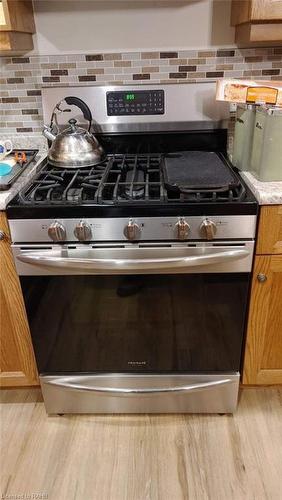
[9,214,256,245]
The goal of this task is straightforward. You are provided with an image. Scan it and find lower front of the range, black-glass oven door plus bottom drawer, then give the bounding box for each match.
[13,242,253,413]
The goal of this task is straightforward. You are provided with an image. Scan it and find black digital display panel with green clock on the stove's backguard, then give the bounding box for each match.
[106,89,165,116]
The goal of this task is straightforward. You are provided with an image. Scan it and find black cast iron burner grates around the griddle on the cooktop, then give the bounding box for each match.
[19,154,245,205]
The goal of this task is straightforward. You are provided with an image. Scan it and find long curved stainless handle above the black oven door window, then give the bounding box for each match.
[17,249,250,272]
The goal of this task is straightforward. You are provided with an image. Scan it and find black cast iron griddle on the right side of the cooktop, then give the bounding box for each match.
[163,151,239,192]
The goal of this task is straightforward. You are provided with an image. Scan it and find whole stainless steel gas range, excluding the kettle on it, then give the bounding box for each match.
[7,84,258,413]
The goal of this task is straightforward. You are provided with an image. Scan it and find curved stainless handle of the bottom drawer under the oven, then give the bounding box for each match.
[45,377,234,396]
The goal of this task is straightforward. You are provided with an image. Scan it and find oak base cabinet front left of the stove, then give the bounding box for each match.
[0,212,38,387]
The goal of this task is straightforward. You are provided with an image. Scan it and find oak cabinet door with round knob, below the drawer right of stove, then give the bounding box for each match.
[243,255,282,384]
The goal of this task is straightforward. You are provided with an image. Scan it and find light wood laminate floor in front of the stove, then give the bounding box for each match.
[0,387,282,500]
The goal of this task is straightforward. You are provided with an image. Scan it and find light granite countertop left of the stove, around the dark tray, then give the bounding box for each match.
[0,135,47,210]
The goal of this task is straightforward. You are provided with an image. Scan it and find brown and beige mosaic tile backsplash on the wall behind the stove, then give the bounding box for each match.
[0,47,282,135]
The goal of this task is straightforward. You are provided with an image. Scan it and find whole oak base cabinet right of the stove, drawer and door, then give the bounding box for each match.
[243,205,282,384]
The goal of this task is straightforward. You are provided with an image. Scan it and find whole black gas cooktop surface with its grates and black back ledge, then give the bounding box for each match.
[7,132,257,219]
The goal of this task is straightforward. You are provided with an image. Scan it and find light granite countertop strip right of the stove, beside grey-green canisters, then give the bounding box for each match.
[241,172,282,205]
